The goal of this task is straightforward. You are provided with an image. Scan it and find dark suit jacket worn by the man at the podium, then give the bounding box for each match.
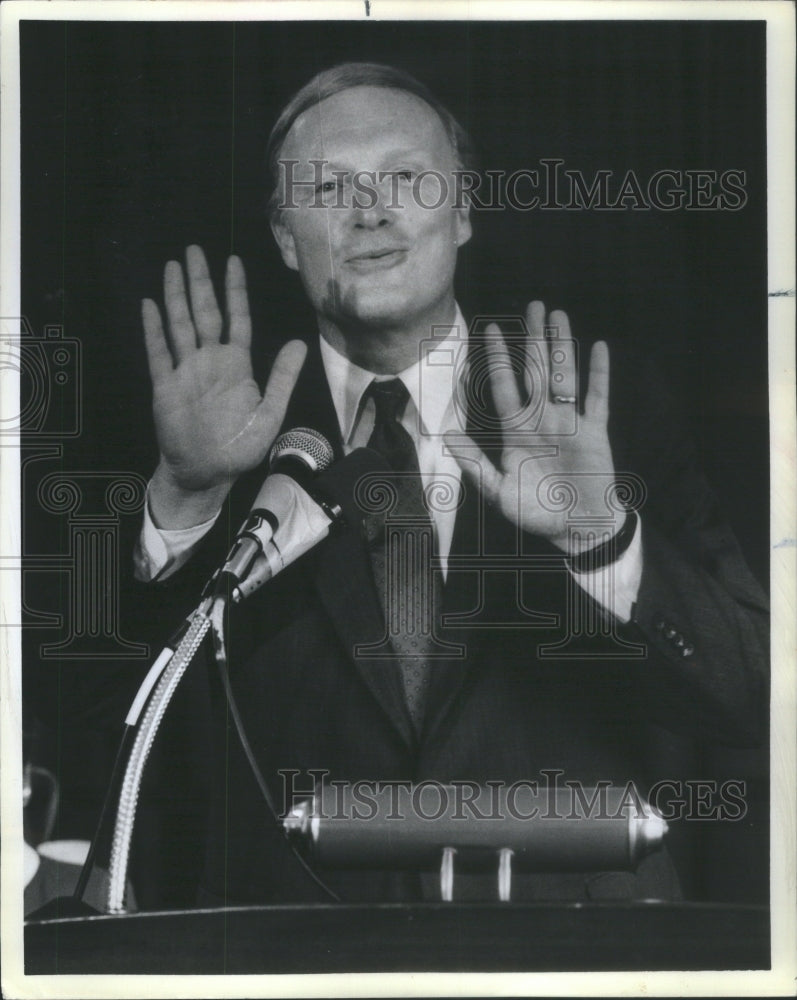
[123,336,768,903]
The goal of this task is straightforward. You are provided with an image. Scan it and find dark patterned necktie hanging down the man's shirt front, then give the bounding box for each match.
[367,378,436,729]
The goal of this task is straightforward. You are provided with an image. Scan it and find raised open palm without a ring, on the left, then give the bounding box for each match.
[142,246,306,527]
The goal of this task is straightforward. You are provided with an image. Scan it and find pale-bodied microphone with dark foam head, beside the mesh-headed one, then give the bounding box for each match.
[225,435,389,603]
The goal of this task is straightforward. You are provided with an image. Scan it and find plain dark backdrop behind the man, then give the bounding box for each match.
[21,21,769,905]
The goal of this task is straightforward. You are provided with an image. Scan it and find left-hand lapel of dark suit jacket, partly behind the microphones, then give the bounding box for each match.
[284,340,416,745]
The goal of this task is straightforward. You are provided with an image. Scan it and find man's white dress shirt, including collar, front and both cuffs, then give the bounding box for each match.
[135,308,642,622]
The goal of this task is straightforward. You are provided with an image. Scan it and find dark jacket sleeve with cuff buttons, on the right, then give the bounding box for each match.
[610,348,769,746]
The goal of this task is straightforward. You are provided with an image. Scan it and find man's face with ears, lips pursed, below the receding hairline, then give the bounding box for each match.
[273,87,471,328]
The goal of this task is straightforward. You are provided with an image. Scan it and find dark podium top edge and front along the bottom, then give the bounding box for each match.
[25,902,770,975]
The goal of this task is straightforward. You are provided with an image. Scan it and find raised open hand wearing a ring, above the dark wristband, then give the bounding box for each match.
[446,302,625,553]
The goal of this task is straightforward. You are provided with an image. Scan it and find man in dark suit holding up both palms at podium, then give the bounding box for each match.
[136,64,766,903]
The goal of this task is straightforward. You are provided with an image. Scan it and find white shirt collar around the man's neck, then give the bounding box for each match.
[320,306,467,444]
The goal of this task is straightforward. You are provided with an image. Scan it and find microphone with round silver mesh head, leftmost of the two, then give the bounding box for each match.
[221,427,332,583]
